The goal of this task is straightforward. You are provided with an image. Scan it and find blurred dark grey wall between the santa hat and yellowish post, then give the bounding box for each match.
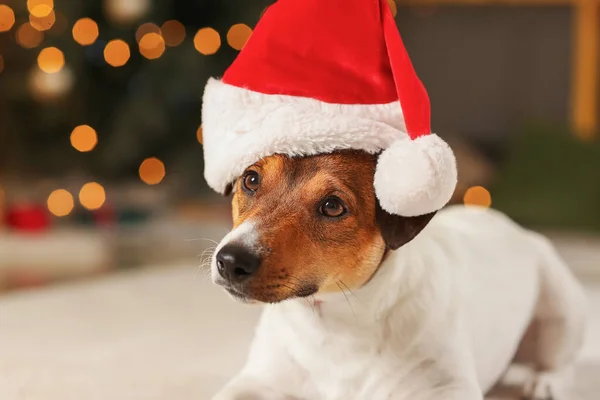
[397,6,572,142]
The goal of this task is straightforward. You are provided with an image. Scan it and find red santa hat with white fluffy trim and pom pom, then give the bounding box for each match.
[202,0,457,216]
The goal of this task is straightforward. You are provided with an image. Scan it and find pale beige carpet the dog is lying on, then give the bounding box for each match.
[0,264,600,400]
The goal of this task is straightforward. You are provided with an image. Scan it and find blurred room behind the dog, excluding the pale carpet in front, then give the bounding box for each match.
[0,0,600,292]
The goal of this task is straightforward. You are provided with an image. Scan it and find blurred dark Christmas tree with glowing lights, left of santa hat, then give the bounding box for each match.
[0,0,272,200]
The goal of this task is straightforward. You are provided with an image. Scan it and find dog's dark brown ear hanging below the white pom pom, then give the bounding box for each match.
[375,202,437,250]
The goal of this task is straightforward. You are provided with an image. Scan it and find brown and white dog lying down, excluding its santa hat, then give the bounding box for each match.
[211,151,586,400]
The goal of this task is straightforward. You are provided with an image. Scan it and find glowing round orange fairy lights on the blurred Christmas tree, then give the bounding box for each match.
[0,0,252,217]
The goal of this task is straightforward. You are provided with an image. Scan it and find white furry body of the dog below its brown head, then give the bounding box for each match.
[213,153,584,400]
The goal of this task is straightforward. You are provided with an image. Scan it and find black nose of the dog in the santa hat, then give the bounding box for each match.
[216,245,260,283]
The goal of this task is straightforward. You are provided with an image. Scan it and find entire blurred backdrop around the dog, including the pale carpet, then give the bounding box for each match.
[0,0,600,400]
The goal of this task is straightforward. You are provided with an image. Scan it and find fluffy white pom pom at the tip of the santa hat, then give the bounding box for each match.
[374,134,458,217]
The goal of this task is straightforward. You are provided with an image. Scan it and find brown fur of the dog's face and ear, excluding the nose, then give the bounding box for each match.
[223,151,433,302]
